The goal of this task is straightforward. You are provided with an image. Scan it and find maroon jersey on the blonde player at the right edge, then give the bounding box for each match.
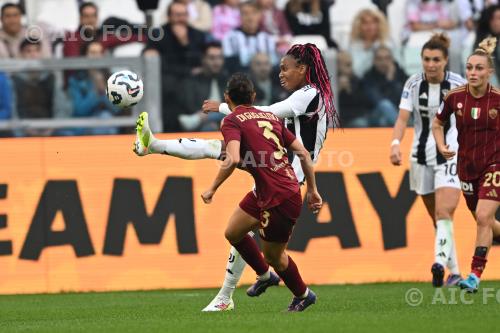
[436,85,500,181]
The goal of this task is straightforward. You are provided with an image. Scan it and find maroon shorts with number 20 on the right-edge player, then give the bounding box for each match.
[461,164,500,212]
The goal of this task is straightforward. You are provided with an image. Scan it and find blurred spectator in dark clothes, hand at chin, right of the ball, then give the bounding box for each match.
[145,2,206,132]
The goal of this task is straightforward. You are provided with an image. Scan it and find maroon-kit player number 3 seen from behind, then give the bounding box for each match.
[202,73,322,311]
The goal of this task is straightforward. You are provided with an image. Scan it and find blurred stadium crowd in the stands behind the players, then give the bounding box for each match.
[0,0,500,136]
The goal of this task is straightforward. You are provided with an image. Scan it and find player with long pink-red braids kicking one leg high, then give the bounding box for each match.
[134,44,339,311]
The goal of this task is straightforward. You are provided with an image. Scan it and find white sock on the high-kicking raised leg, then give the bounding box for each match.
[149,138,222,160]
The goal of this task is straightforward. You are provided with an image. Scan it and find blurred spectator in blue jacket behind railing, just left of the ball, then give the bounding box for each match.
[64,41,118,135]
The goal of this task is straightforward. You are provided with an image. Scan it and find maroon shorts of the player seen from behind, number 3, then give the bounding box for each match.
[240,191,302,243]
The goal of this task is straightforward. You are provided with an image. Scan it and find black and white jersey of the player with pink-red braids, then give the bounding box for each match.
[219,85,328,182]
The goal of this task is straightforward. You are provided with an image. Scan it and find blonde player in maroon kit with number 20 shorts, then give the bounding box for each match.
[432,37,500,292]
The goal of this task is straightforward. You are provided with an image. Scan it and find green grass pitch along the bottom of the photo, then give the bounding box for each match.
[0,282,500,333]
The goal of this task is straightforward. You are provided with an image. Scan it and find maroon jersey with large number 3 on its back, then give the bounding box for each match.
[221,106,300,209]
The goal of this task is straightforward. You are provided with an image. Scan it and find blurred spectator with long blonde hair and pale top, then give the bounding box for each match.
[349,9,393,78]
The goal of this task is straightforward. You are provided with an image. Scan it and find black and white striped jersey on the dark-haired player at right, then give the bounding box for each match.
[399,72,466,165]
